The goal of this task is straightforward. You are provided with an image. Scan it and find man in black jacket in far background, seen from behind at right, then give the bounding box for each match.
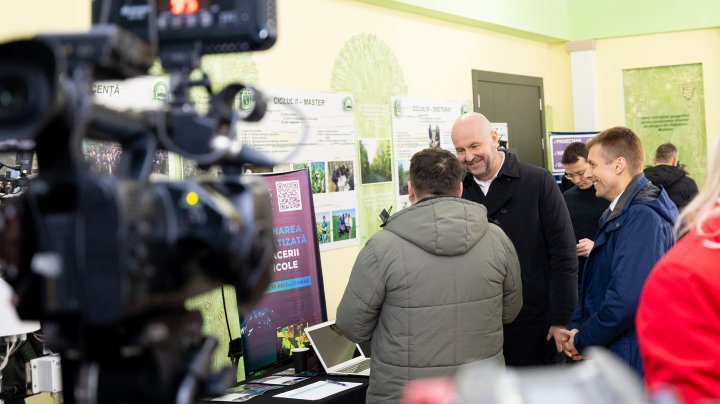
[645,143,698,210]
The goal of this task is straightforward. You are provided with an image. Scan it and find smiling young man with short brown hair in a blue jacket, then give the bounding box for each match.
[563,127,678,375]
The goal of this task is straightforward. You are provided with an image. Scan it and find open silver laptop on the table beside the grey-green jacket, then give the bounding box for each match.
[305,320,370,376]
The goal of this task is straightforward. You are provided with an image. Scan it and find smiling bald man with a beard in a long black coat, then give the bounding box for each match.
[451,112,578,366]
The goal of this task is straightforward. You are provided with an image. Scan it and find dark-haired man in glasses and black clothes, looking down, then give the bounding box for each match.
[560,142,610,280]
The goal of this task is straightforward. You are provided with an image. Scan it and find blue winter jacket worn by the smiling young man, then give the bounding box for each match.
[568,174,678,375]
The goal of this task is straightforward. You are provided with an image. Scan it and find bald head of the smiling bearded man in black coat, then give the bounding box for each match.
[451,112,502,181]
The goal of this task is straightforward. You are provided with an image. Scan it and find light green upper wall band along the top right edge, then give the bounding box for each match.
[359,0,720,43]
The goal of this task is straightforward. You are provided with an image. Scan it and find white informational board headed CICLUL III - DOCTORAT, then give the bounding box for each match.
[392,97,467,211]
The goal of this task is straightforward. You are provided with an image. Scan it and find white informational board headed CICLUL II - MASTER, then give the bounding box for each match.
[237,89,361,250]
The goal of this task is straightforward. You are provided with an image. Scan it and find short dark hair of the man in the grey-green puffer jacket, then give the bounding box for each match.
[410,147,463,197]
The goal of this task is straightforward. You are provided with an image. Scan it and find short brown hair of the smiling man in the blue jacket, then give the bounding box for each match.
[586,126,645,175]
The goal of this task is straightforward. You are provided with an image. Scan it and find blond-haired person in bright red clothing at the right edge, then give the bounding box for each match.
[636,140,720,404]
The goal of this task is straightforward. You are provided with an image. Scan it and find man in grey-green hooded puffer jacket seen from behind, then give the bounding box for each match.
[336,148,522,403]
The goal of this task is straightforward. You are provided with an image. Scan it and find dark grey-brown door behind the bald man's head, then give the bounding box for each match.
[472,70,547,168]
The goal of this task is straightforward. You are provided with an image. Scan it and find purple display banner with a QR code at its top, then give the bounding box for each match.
[241,170,327,379]
